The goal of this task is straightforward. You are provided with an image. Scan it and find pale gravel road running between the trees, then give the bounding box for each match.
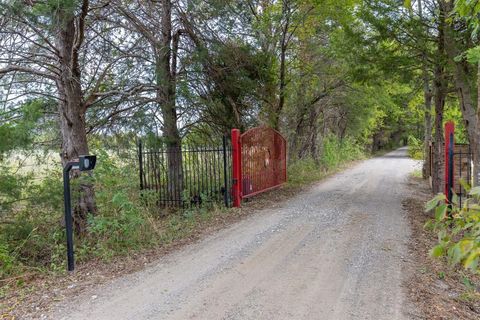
[51,149,416,320]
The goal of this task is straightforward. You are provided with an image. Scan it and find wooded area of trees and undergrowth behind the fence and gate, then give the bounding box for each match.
[0,0,480,277]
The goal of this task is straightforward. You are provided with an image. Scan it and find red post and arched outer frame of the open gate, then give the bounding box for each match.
[231,127,287,208]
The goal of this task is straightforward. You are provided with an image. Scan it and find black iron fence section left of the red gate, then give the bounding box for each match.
[138,137,232,208]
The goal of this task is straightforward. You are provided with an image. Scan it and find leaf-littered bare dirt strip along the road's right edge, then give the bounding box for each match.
[403,177,480,320]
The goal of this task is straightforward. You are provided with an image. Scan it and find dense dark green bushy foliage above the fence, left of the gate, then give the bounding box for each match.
[186,39,275,133]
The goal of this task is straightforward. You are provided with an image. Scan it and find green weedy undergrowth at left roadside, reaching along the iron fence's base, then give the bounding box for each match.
[0,149,231,279]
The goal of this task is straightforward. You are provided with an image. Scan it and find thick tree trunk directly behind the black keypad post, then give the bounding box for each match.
[56,4,96,234]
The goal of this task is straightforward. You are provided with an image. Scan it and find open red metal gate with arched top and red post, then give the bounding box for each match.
[232,127,287,207]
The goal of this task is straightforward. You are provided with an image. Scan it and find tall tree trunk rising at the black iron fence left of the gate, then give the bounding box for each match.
[160,0,183,200]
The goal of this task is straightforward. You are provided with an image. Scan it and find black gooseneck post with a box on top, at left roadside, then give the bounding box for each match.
[63,156,97,271]
